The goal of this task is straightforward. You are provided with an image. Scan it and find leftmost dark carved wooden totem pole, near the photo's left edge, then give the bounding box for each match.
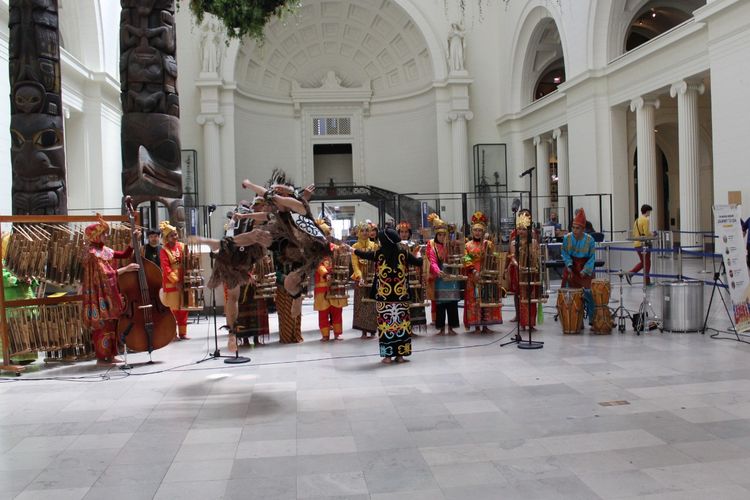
[8,0,68,215]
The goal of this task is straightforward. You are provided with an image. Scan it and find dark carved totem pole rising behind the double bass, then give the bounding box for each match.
[120,0,185,226]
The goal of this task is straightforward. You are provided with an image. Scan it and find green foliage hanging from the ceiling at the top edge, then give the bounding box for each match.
[183,0,300,40]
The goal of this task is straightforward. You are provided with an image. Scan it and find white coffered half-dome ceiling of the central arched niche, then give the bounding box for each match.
[235,0,434,99]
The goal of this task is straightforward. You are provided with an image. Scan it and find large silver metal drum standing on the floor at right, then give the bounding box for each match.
[659,281,705,332]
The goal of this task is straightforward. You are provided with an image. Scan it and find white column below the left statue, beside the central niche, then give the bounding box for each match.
[197,115,225,236]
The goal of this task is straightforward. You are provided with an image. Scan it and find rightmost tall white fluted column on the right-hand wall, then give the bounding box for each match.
[669,80,706,251]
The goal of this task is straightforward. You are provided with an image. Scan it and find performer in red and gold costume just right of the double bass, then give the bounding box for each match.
[159,221,190,340]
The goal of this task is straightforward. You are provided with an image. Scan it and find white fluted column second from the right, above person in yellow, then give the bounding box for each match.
[630,97,661,231]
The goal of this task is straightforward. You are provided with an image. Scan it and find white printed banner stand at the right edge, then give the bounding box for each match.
[708,205,750,333]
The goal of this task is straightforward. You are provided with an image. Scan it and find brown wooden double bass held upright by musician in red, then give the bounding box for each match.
[117,196,177,354]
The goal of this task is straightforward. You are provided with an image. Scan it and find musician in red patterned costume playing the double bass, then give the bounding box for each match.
[81,218,133,361]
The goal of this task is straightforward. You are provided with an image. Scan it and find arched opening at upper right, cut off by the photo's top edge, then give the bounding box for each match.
[625,0,706,52]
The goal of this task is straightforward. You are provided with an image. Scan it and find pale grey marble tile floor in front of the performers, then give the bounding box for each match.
[0,262,750,500]
